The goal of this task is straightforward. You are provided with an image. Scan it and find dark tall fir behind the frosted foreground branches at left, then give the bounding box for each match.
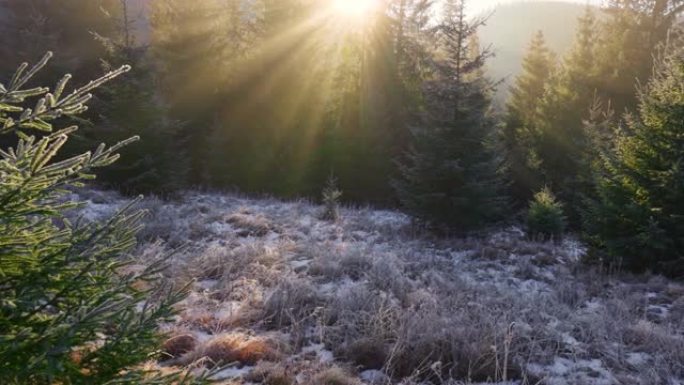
[79,0,189,195]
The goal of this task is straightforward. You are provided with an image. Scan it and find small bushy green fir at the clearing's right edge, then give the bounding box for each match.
[527,187,566,240]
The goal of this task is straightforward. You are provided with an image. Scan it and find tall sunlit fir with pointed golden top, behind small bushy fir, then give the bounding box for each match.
[533,7,598,226]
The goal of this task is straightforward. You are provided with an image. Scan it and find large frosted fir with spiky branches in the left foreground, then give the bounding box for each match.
[0,54,208,384]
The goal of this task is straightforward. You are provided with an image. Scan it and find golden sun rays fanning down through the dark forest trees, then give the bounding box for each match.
[146,0,428,203]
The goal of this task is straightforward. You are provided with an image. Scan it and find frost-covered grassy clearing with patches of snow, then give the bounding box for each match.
[72,191,684,385]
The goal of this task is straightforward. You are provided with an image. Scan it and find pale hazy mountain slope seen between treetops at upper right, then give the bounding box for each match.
[480,1,586,101]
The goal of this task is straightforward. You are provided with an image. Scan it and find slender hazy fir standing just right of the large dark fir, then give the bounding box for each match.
[502,31,554,203]
